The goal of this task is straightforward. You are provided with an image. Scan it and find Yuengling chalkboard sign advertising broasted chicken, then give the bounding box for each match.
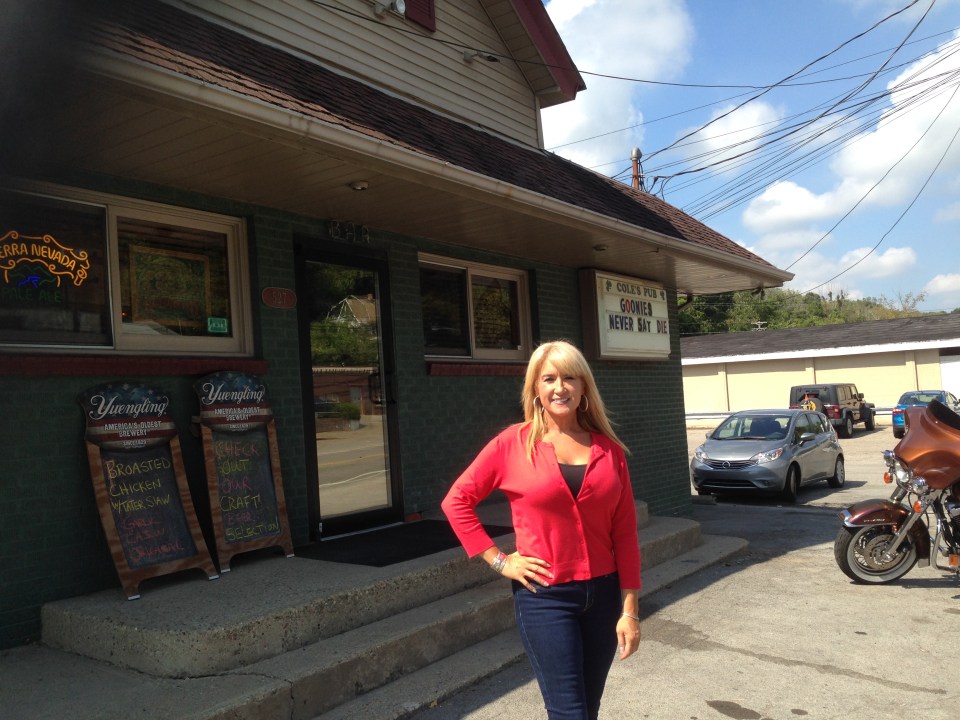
[79,383,218,600]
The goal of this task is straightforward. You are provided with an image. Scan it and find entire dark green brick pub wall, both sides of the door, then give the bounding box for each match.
[0,177,691,648]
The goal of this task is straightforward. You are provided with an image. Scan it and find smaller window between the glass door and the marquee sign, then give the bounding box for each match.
[420,255,531,360]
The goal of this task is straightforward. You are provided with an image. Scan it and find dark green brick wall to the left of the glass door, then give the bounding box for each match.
[0,177,321,648]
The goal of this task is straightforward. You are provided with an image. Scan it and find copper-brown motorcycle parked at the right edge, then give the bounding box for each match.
[833,400,960,584]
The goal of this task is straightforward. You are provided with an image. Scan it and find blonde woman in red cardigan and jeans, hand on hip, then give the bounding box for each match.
[442,341,640,720]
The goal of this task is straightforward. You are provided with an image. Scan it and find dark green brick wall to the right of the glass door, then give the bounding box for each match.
[391,241,692,515]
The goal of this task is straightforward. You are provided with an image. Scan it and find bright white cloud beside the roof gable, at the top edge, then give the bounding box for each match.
[542,0,693,174]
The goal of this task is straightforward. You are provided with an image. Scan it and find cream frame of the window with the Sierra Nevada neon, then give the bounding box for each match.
[8,183,253,357]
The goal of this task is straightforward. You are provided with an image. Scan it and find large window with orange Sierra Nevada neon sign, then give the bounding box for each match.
[0,184,252,355]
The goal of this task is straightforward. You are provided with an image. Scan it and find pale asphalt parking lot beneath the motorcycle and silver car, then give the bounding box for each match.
[415,426,960,720]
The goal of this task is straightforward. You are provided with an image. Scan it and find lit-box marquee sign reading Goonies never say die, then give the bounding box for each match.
[580,270,670,360]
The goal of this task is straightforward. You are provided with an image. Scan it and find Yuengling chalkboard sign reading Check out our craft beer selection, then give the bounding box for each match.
[194,372,293,572]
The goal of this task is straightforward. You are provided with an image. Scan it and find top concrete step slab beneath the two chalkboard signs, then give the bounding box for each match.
[41,535,513,678]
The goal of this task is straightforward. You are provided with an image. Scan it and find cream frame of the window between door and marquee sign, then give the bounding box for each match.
[417,253,533,362]
